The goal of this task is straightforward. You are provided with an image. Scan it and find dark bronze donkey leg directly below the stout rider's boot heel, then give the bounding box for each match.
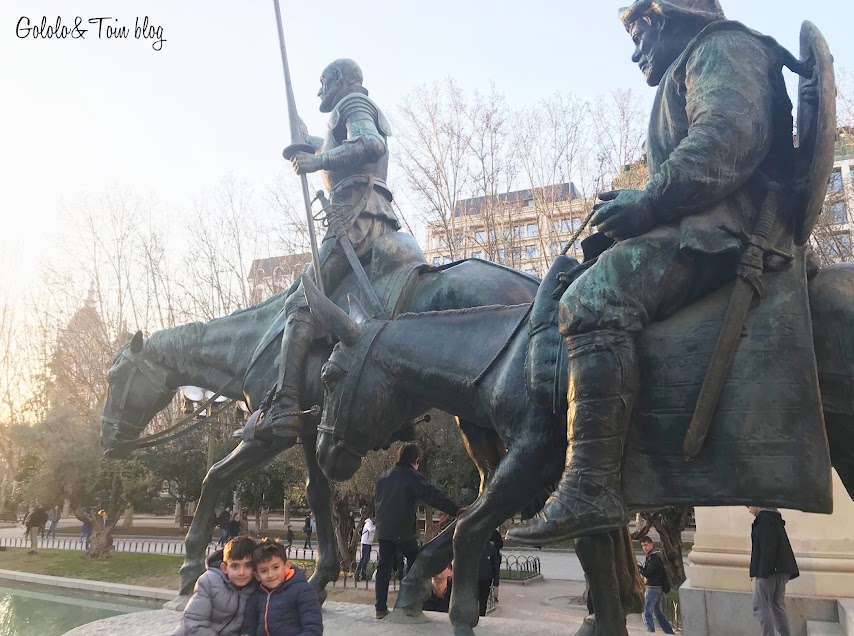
[575,532,628,636]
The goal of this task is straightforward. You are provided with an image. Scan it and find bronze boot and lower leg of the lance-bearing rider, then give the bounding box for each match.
[261,307,314,437]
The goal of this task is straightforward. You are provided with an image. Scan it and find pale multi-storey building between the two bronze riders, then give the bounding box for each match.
[425,183,592,277]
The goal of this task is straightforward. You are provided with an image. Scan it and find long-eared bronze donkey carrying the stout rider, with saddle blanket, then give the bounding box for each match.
[304,255,854,635]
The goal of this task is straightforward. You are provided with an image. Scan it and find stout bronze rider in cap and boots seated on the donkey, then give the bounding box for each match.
[512,0,808,543]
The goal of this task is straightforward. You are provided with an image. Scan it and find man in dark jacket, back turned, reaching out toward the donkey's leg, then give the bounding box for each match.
[376,444,463,618]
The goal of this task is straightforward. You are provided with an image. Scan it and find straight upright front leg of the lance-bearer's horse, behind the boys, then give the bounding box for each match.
[302,434,341,603]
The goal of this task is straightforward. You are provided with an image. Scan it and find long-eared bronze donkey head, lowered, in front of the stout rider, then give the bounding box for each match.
[303,276,424,481]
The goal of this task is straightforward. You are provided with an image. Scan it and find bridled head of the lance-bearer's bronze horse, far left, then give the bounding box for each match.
[101,331,178,458]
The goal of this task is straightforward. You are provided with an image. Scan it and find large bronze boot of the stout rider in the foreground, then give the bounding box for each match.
[510,330,638,545]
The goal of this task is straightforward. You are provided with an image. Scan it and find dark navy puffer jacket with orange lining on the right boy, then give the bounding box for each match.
[240,567,323,636]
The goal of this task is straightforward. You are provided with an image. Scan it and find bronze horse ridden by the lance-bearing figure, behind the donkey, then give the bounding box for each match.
[101,232,538,597]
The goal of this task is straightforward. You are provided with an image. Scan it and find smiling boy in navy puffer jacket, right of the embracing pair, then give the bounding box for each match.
[240,539,323,636]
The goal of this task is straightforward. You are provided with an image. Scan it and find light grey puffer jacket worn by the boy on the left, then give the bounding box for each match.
[172,550,258,636]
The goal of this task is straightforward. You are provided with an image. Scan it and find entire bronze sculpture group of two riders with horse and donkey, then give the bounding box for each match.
[102,0,854,636]
